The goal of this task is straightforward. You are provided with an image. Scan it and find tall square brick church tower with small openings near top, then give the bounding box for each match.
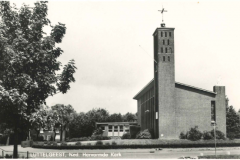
[153,23,176,138]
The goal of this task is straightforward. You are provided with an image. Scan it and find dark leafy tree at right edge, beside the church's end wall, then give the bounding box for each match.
[226,106,240,137]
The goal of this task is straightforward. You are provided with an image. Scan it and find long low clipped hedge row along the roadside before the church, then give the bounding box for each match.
[32,142,240,149]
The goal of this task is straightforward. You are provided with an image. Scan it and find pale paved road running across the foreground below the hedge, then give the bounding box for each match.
[0,146,240,159]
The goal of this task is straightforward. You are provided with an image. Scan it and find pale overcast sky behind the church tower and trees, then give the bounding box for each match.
[12,0,240,114]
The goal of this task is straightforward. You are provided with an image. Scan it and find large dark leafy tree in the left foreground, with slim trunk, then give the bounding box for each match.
[0,1,76,158]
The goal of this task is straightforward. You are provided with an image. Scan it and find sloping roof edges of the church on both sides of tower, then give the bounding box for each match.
[133,79,217,100]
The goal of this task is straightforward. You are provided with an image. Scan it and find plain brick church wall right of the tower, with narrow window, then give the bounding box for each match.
[175,86,226,136]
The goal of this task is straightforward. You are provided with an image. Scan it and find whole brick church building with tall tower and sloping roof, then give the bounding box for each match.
[133,24,226,139]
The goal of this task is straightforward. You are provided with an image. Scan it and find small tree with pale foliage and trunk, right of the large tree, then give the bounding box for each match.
[51,104,76,141]
